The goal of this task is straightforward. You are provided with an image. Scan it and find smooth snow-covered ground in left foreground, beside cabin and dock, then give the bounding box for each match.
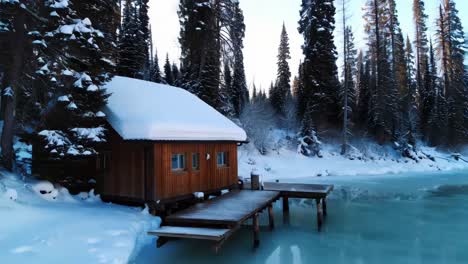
[0,171,159,264]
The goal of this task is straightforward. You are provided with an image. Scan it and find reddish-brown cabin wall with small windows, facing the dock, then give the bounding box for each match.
[153,142,238,201]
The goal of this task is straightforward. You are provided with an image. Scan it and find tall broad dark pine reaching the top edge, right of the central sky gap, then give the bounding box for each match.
[298,0,340,130]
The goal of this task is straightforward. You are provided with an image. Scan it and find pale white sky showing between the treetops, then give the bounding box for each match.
[149,0,468,93]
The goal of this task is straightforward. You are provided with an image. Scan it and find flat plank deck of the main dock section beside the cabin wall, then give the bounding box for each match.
[165,190,279,226]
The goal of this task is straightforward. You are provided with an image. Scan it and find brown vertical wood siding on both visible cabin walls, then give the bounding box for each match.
[100,130,237,201]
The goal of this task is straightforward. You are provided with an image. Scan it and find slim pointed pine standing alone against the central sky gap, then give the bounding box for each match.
[270,23,291,117]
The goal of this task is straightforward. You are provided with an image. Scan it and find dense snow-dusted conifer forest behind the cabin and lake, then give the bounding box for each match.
[0,0,468,170]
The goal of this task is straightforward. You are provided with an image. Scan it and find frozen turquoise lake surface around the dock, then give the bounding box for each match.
[134,171,468,264]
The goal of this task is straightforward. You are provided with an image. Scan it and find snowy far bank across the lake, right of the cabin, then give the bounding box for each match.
[239,131,468,181]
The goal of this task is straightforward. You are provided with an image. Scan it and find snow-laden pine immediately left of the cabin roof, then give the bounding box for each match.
[37,2,115,159]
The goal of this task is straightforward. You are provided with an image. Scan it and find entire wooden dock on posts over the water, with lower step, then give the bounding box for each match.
[148,183,333,252]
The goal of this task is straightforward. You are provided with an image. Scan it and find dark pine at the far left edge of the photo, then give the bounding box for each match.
[0,1,36,170]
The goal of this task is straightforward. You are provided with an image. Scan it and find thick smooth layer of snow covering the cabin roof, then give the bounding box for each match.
[103,76,247,142]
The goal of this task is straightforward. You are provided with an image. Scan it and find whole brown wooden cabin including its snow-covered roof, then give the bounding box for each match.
[96,77,246,203]
